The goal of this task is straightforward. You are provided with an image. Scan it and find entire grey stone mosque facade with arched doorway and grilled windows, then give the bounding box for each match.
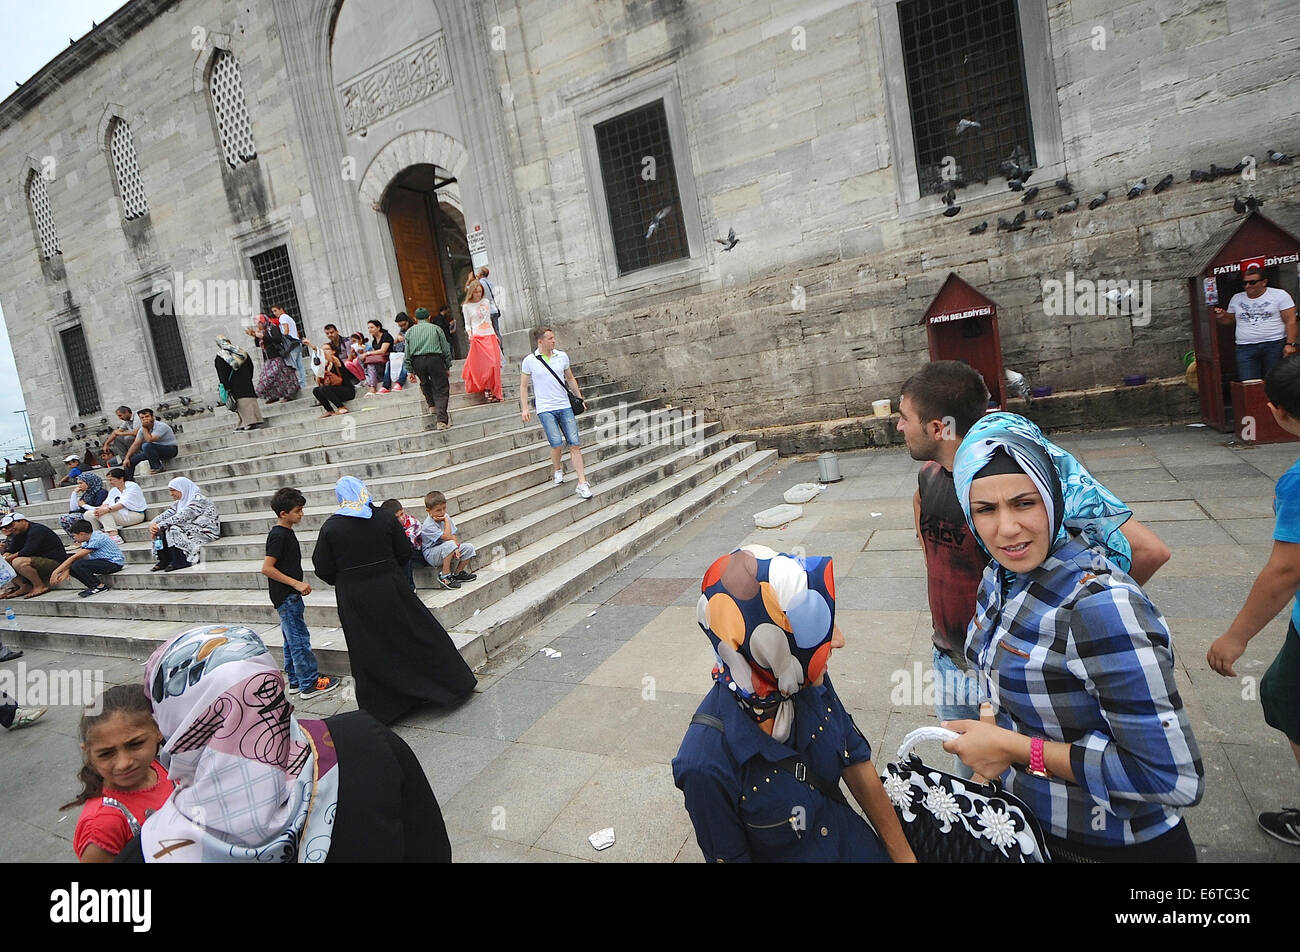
[0,0,1300,443]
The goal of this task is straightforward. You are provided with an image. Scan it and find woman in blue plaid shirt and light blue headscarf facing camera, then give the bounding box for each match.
[944,414,1205,862]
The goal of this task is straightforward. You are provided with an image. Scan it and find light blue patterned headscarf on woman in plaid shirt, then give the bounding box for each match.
[953,412,1132,572]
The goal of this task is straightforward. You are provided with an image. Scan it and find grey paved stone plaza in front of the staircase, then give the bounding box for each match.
[0,425,1300,862]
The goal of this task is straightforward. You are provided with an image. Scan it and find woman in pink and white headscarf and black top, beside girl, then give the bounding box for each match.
[117,626,451,862]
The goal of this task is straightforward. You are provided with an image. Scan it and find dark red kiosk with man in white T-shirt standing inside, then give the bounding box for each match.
[1187,212,1300,443]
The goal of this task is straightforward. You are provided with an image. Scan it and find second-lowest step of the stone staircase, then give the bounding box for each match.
[0,433,775,634]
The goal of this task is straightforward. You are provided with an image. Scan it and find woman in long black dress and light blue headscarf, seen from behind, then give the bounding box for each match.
[312,476,477,724]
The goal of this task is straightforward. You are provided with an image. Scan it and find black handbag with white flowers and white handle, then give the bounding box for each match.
[880,727,1052,862]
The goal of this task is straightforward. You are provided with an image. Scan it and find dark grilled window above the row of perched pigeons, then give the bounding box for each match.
[898,0,1036,195]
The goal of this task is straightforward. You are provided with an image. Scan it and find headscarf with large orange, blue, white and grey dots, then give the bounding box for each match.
[697,545,835,743]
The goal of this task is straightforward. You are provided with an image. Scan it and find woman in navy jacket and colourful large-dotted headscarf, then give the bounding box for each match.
[672,545,915,862]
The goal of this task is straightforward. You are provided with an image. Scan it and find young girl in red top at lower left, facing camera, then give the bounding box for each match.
[60,684,173,862]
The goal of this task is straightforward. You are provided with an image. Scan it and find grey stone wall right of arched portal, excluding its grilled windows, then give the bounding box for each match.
[493,0,1300,428]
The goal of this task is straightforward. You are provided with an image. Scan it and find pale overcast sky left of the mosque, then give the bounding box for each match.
[0,0,124,460]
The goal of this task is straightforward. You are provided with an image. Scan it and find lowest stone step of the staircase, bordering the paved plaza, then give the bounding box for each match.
[5,450,776,674]
